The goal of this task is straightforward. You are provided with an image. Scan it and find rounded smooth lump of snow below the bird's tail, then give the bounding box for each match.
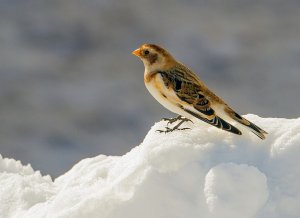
[204,163,268,217]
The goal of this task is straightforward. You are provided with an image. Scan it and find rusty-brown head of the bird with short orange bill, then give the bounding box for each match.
[132,44,175,71]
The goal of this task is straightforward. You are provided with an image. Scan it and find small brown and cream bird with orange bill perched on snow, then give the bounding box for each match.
[132,44,268,139]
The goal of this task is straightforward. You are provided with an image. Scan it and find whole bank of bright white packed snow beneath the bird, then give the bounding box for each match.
[0,115,300,218]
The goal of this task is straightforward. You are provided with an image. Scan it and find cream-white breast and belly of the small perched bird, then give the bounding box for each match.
[145,74,189,117]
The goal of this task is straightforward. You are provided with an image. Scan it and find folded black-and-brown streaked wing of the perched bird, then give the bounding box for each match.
[159,68,242,135]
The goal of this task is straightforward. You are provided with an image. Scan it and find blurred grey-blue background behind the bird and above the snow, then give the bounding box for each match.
[0,0,300,177]
